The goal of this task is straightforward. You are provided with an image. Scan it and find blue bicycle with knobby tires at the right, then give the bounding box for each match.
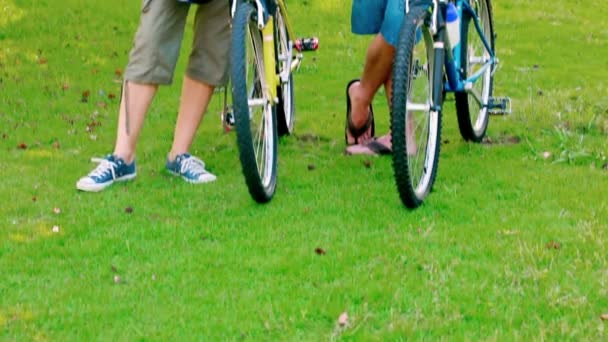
[391,0,511,208]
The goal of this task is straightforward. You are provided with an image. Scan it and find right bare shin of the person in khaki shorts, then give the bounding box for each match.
[169,76,215,160]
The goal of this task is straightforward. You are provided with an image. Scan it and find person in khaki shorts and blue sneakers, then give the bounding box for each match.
[76,0,231,192]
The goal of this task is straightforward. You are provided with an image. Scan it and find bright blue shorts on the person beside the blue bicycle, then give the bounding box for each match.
[351,0,405,46]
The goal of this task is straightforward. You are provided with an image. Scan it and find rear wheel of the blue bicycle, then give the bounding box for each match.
[455,0,495,142]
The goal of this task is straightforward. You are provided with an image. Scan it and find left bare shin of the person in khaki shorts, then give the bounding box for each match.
[114,82,158,164]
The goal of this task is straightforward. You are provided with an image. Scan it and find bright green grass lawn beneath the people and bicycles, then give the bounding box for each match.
[0,0,608,341]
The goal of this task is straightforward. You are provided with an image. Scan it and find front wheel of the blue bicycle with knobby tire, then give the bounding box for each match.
[391,6,443,209]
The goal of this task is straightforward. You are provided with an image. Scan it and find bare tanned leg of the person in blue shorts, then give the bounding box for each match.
[347,34,395,144]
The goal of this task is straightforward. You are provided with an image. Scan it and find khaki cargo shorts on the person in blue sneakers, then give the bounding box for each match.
[124,0,231,86]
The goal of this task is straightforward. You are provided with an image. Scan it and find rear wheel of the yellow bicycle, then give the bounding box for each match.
[274,7,295,136]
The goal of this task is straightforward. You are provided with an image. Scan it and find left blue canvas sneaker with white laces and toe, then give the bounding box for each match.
[76,155,136,192]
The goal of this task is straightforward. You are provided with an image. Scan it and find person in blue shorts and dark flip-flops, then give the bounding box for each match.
[344,0,405,154]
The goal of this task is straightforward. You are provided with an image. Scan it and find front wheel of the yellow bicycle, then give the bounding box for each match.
[231,3,277,203]
